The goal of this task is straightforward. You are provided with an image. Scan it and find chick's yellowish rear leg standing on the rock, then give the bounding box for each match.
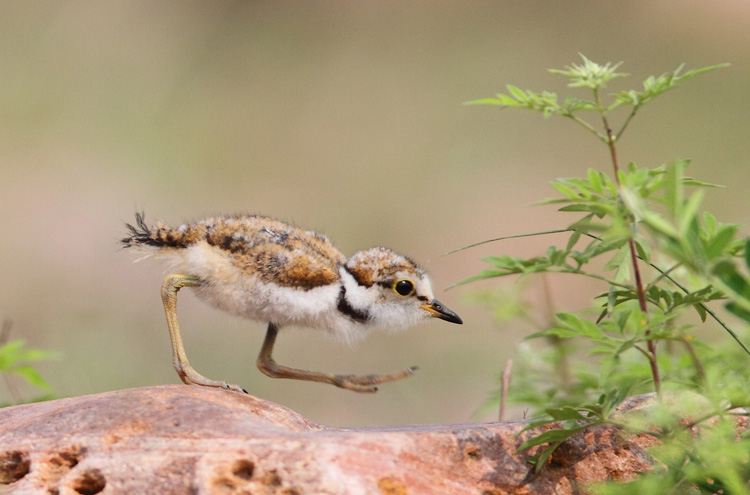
[161,273,247,393]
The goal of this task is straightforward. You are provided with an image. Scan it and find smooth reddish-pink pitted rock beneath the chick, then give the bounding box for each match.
[0,385,653,495]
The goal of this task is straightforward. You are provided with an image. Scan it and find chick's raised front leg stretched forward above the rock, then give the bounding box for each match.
[257,323,417,393]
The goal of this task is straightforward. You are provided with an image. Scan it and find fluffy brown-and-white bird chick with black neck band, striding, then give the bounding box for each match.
[121,213,463,393]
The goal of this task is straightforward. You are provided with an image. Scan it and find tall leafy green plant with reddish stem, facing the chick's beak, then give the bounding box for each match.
[460,56,750,494]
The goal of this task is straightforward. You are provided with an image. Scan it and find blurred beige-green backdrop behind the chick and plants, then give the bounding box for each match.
[0,0,750,425]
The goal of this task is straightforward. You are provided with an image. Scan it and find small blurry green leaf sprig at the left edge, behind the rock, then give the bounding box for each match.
[0,320,57,407]
